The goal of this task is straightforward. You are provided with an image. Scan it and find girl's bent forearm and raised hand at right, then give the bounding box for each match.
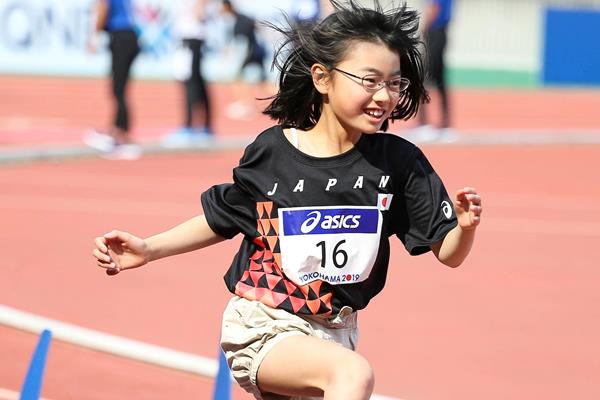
[431,187,482,268]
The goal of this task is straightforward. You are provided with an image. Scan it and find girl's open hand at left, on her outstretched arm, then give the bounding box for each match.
[92,230,150,275]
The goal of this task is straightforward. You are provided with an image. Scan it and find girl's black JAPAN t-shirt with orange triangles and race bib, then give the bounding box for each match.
[202,126,456,315]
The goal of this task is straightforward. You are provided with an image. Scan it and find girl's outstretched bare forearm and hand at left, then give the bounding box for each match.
[92,215,225,275]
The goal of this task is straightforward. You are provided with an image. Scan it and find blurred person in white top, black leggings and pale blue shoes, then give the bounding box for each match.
[163,0,213,146]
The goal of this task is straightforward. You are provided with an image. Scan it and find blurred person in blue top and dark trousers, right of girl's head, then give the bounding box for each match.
[414,0,454,142]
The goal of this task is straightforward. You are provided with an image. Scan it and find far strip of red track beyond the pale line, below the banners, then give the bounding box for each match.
[0,76,600,146]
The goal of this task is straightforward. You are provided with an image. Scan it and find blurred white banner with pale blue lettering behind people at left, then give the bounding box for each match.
[0,0,319,80]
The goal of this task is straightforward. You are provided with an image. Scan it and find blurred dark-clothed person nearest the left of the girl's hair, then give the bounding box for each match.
[222,0,267,119]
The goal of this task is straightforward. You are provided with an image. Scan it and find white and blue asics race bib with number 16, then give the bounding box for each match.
[279,206,382,285]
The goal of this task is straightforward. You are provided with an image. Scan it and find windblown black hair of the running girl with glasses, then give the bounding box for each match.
[263,0,429,131]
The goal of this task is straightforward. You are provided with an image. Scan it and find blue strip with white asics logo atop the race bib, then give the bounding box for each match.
[280,207,379,235]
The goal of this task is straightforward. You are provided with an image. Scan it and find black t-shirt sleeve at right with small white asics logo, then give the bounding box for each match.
[397,149,457,255]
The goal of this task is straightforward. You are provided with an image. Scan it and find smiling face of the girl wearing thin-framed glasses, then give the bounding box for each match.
[327,42,401,134]
